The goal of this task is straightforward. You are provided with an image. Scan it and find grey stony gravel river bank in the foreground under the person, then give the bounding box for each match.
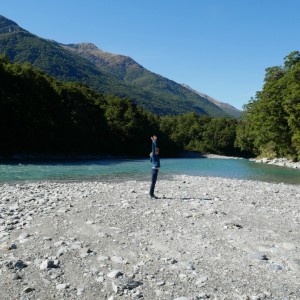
[0,176,300,300]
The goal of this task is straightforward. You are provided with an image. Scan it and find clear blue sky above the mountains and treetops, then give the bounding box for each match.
[0,0,300,109]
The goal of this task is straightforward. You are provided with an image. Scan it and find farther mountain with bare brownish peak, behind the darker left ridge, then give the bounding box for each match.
[62,43,241,118]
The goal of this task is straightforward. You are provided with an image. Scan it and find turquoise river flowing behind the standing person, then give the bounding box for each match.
[0,158,300,184]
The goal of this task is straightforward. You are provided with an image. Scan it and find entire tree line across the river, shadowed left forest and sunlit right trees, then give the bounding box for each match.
[0,51,300,160]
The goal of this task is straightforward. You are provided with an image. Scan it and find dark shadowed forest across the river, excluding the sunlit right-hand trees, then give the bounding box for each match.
[0,56,241,156]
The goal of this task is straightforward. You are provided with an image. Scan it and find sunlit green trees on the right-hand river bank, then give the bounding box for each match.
[235,51,300,160]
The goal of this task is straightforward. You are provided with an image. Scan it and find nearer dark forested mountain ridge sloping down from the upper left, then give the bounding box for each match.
[0,16,134,93]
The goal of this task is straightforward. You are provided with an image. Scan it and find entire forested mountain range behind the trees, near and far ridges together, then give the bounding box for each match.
[0,16,234,117]
